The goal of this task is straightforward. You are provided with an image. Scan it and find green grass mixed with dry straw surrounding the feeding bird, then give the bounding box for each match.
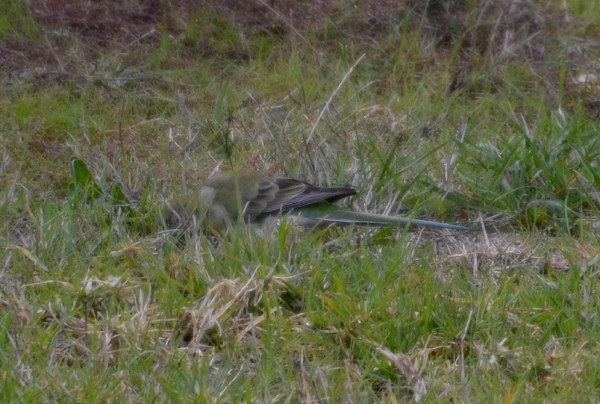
[0,1,600,402]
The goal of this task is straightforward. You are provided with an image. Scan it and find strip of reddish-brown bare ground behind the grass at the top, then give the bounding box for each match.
[2,0,592,68]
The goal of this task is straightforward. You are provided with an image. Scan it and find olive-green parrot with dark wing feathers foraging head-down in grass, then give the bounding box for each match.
[160,170,474,234]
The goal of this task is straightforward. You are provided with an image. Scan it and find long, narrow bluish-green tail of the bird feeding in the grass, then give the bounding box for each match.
[292,205,477,231]
